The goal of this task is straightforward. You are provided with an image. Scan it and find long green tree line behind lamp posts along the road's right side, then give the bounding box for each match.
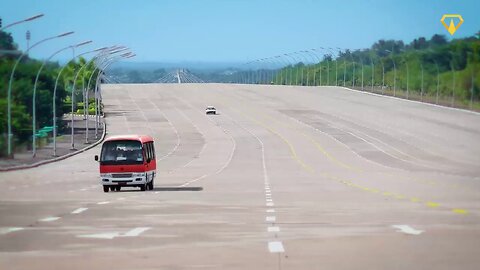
[270,35,480,110]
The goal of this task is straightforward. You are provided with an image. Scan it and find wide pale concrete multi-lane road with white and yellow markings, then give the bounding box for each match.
[0,84,480,270]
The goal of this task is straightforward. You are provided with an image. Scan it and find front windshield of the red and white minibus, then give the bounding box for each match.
[100,140,143,165]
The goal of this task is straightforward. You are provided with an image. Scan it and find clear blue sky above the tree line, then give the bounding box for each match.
[0,0,480,62]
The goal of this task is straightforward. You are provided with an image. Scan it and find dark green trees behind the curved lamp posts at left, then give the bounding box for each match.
[0,32,99,156]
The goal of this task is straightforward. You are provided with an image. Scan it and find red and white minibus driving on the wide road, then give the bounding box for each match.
[95,135,157,192]
